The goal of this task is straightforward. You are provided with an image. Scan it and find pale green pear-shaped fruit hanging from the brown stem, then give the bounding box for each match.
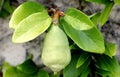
[42,24,71,73]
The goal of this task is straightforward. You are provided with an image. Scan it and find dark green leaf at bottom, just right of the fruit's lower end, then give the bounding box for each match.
[63,54,90,77]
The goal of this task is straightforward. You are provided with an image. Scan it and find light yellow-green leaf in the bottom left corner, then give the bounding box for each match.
[3,66,29,77]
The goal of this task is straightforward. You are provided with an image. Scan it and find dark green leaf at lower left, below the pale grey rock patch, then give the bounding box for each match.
[17,59,38,74]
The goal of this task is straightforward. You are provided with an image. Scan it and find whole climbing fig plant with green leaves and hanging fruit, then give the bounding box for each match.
[3,0,120,77]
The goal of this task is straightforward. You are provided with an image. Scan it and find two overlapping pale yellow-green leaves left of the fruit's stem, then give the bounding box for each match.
[9,1,52,43]
